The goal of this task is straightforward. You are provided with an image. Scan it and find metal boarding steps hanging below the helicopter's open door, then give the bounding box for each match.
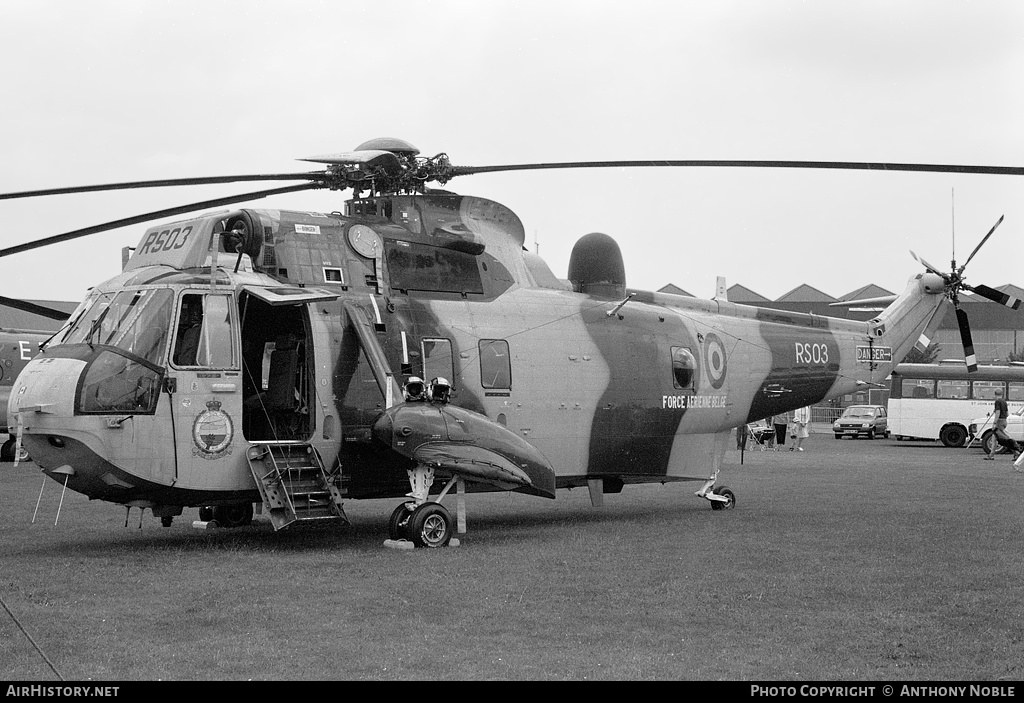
[246,443,348,530]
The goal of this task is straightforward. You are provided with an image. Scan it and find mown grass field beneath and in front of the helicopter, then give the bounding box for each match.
[0,435,1024,682]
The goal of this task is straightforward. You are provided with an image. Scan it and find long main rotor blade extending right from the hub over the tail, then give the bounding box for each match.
[452,159,1024,176]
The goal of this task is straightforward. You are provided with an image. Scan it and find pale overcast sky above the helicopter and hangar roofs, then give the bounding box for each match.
[0,0,1024,300]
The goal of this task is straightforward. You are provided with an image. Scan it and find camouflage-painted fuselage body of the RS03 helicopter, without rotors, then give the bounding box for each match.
[11,193,944,507]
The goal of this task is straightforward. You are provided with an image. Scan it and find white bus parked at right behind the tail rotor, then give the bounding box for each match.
[889,362,1024,447]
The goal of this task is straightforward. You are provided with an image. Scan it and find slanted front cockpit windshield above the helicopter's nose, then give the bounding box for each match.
[61,289,174,365]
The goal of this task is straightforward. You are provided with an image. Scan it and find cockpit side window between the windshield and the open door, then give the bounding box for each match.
[173,293,238,368]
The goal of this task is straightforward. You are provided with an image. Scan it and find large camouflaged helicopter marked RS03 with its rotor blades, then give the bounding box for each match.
[0,138,1024,547]
